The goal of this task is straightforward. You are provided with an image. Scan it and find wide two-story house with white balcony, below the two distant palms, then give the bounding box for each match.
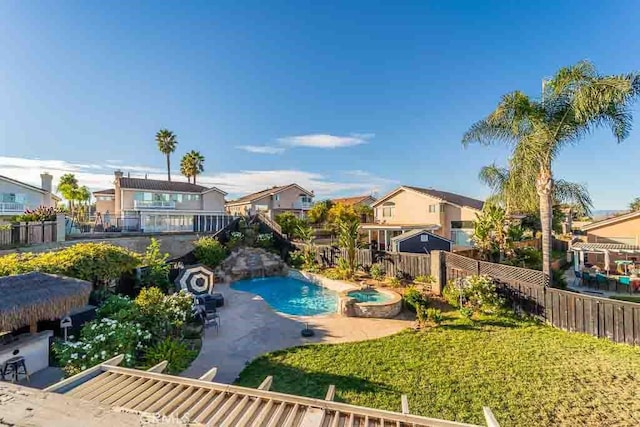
[93,171,228,232]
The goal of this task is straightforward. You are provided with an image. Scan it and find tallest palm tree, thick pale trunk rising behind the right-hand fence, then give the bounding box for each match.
[462,61,640,284]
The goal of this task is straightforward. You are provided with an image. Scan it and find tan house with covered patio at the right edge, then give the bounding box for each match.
[572,211,640,271]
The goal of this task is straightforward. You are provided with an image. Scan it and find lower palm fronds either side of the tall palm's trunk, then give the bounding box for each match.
[478,163,593,215]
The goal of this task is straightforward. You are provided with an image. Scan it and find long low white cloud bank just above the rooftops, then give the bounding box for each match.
[0,156,397,200]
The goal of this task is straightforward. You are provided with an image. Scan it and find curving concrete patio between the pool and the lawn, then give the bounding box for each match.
[181,284,412,383]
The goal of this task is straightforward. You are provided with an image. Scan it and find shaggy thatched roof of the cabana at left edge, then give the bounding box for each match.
[0,272,91,331]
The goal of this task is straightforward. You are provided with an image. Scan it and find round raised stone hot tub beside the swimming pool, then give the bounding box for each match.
[340,288,402,319]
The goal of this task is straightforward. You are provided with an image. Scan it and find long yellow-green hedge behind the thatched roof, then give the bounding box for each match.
[0,243,140,284]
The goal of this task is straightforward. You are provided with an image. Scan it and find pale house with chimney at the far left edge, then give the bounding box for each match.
[0,172,60,218]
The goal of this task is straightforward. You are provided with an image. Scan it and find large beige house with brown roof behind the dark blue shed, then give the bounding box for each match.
[361,185,484,250]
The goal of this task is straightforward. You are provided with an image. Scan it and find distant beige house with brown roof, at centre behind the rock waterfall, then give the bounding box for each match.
[226,184,313,219]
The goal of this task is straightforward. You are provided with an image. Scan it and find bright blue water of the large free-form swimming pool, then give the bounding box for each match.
[231,277,338,316]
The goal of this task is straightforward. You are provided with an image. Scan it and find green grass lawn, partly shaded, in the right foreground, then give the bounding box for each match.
[237,313,640,427]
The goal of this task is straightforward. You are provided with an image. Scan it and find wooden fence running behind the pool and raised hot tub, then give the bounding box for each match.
[293,243,431,279]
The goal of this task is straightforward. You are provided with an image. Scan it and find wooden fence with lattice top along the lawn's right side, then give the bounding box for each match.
[443,253,640,345]
